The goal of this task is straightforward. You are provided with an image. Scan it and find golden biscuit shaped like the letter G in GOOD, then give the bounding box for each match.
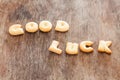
[9,24,24,35]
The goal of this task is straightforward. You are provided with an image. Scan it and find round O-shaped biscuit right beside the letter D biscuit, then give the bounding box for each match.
[39,21,52,32]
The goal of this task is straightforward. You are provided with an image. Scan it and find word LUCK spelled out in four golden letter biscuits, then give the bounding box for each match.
[48,40,112,54]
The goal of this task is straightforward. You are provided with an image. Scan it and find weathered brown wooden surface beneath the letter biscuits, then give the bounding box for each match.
[0,0,120,80]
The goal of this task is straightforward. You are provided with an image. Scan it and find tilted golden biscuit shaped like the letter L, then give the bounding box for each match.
[48,40,62,54]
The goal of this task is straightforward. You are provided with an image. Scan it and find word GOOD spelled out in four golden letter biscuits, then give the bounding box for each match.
[9,20,69,35]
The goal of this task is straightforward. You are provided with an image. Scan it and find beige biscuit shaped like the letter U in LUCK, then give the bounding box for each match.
[66,42,78,54]
